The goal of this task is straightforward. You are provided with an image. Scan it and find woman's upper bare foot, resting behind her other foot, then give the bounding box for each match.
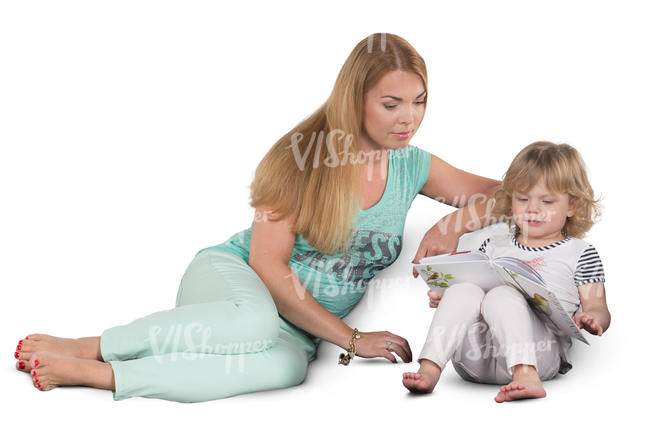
[14,334,103,366]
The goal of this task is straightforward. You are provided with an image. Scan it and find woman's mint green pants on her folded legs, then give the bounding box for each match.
[100,250,316,402]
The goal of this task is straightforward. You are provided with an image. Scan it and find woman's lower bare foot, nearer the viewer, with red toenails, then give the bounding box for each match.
[29,352,115,391]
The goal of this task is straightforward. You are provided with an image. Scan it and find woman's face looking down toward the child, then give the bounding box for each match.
[360,71,426,152]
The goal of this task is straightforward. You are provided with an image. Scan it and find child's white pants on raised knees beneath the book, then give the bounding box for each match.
[418,283,561,384]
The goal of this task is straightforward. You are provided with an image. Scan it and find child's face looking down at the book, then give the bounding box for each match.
[512,180,575,243]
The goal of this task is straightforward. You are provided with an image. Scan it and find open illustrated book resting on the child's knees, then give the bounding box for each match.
[414,251,589,344]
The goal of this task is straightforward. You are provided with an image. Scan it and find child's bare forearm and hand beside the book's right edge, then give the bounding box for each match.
[573,283,611,335]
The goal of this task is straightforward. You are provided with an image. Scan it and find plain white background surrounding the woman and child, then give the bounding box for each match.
[0,1,650,432]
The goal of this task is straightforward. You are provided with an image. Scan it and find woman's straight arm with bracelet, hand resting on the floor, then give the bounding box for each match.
[249,207,412,362]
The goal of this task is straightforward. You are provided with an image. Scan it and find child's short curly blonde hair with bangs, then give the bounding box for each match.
[492,141,601,238]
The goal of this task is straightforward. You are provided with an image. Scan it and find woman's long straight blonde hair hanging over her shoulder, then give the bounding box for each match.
[249,33,427,254]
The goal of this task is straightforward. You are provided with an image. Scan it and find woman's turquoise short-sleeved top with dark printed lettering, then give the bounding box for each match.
[197,145,431,318]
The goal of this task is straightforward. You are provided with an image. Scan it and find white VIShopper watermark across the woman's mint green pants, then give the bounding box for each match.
[145,322,274,371]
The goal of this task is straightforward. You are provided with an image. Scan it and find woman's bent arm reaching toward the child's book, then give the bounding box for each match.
[413,155,501,276]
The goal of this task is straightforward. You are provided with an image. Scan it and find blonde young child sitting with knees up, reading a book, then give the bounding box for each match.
[402,142,610,403]
